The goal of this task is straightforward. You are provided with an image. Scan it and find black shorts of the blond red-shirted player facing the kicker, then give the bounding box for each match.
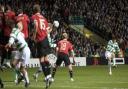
[56,53,70,66]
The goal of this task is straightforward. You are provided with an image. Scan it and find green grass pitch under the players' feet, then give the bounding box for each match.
[0,65,128,89]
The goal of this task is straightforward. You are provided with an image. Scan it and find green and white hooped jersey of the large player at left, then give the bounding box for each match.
[9,28,28,49]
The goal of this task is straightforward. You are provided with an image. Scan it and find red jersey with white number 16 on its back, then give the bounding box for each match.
[32,13,48,42]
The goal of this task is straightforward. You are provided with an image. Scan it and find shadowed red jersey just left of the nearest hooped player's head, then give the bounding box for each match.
[4,10,15,37]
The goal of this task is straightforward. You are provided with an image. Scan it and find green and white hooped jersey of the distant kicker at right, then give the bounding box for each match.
[106,40,120,53]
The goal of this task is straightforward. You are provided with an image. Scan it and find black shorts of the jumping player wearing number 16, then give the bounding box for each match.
[37,37,51,58]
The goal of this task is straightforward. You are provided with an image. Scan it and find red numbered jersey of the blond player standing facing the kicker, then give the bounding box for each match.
[57,39,73,54]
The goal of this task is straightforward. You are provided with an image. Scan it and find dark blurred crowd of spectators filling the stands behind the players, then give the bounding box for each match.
[0,0,128,60]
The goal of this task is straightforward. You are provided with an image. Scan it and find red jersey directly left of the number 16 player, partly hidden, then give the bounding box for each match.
[16,14,30,38]
